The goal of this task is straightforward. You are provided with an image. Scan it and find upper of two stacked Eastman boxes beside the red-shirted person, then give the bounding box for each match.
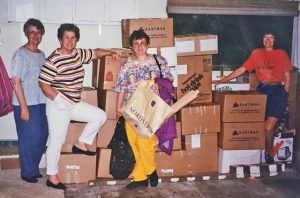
[213,91,267,122]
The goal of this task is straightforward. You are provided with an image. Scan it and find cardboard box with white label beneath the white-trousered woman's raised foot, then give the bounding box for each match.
[58,153,96,184]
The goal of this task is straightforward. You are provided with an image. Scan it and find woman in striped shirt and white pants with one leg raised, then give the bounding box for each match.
[39,24,119,189]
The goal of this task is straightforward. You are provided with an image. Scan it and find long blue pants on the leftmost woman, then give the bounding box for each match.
[14,104,48,177]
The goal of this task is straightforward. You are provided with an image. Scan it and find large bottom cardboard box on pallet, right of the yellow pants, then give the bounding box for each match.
[155,133,218,177]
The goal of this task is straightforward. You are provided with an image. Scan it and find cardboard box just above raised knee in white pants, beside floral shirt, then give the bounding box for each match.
[98,89,117,120]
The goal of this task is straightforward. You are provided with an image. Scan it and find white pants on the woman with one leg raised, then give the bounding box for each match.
[46,95,107,175]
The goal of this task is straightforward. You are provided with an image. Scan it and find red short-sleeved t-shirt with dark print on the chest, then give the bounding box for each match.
[242,48,292,82]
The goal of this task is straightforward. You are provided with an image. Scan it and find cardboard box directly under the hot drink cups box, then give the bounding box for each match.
[180,103,221,135]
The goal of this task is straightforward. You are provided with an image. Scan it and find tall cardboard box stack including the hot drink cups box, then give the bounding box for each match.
[156,34,220,177]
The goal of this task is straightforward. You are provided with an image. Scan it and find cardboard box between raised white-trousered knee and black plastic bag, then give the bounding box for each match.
[97,120,118,148]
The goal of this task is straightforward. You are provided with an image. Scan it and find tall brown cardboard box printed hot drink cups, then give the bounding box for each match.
[177,55,212,104]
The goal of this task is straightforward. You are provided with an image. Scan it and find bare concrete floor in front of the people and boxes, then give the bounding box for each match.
[0,167,300,198]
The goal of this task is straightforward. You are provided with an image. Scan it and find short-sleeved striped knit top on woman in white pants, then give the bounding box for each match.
[39,48,94,103]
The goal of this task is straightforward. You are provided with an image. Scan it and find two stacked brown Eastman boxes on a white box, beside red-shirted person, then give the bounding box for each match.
[214,91,266,173]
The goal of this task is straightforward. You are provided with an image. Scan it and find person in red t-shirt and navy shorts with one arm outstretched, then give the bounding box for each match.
[213,33,292,164]
